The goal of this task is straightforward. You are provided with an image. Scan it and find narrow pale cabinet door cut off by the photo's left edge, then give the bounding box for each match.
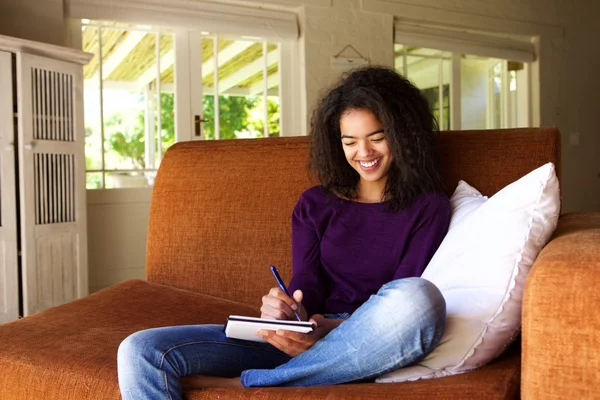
[0,51,19,323]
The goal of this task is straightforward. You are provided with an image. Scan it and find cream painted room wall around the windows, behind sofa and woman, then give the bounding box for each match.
[0,0,600,291]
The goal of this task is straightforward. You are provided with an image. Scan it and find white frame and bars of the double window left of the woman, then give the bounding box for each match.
[78,21,299,190]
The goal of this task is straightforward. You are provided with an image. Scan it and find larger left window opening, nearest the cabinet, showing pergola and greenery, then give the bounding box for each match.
[82,21,175,189]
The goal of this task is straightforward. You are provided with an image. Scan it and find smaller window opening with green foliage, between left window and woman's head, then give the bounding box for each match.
[198,36,280,139]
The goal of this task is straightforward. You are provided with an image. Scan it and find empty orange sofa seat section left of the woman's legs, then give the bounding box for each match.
[0,280,258,400]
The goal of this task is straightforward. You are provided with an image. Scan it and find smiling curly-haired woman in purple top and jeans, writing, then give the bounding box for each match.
[118,67,450,400]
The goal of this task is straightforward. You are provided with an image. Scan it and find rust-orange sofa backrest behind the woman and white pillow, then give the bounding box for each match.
[146,128,560,306]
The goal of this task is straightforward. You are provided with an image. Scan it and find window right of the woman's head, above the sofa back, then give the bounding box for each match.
[395,44,529,130]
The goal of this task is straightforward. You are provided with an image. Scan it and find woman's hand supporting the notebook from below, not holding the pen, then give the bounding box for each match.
[258,314,337,357]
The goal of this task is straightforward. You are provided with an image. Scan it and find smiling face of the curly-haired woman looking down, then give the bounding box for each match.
[340,109,392,186]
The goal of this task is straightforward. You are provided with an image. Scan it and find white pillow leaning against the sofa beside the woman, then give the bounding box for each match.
[377,163,560,383]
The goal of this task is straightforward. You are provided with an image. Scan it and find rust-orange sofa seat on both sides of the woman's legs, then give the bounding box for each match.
[0,280,520,400]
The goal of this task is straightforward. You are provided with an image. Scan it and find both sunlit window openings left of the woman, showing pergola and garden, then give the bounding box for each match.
[82,20,281,189]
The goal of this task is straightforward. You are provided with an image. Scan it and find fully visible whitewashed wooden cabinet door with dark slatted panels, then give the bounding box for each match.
[17,53,88,316]
